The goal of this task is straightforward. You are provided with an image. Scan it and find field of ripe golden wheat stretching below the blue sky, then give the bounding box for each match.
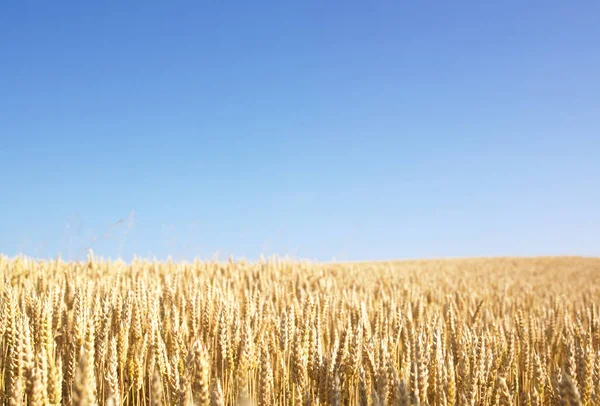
[0,256,600,406]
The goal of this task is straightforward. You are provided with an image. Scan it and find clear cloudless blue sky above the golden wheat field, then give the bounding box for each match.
[0,0,600,260]
